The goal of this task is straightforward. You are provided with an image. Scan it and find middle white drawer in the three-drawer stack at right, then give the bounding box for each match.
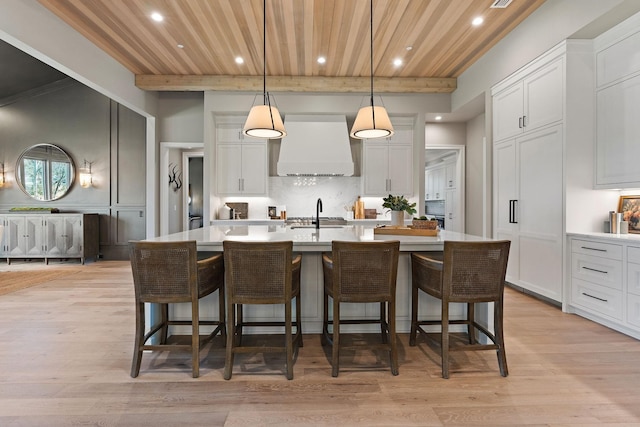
[571,253,622,291]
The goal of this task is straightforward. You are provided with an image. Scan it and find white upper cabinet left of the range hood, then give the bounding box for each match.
[216,117,268,196]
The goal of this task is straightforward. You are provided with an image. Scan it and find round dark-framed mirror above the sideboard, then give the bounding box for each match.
[16,144,75,202]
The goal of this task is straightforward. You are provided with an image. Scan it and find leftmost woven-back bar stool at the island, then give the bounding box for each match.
[129,241,226,378]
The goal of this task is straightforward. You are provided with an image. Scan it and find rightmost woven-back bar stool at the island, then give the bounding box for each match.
[409,240,511,378]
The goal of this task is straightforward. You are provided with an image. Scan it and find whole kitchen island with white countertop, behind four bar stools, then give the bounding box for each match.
[148,223,491,333]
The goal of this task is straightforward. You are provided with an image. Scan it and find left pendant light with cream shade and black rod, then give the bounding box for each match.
[243,0,287,139]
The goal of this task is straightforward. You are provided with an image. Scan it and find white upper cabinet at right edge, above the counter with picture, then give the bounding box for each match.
[595,17,640,188]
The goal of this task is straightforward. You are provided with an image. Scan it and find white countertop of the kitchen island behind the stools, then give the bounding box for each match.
[148,226,492,252]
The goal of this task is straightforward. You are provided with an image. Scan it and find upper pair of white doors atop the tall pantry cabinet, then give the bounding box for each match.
[493,58,564,141]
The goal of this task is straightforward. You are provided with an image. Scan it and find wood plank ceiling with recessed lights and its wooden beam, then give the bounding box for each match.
[39,0,544,93]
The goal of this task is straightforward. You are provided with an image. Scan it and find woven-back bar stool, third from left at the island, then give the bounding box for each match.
[322,240,400,377]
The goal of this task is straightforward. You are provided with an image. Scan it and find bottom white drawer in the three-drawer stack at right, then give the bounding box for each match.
[571,278,622,320]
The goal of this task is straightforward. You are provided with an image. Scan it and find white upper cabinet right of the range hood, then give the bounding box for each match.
[362,124,413,196]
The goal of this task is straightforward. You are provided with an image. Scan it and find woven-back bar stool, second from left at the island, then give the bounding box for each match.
[222,240,302,380]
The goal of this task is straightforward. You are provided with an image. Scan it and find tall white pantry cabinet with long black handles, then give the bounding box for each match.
[491,41,606,303]
